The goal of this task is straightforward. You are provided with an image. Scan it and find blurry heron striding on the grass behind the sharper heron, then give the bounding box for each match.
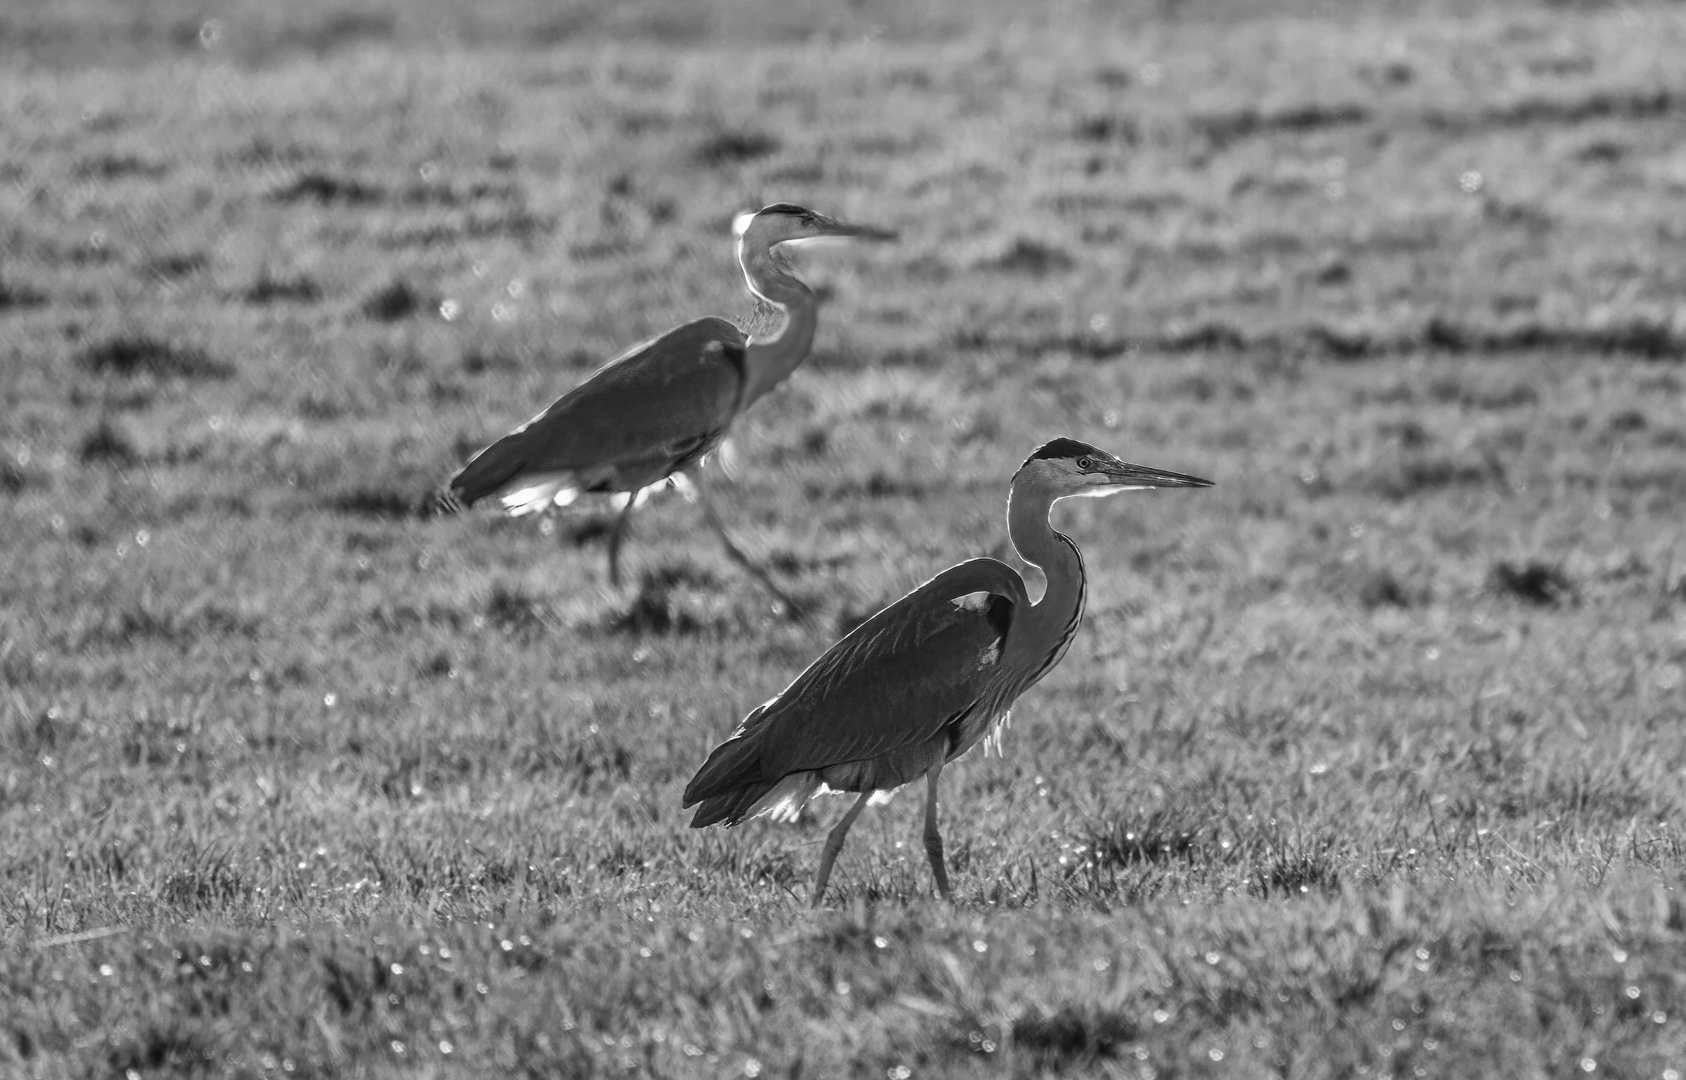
[438,202,895,608]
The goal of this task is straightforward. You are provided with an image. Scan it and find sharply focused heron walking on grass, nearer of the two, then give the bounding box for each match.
[685,438,1212,906]
